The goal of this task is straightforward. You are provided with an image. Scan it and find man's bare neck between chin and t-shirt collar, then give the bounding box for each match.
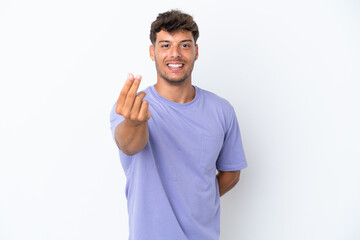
[154,78,195,103]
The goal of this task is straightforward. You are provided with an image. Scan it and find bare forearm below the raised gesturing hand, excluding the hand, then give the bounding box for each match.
[115,119,149,155]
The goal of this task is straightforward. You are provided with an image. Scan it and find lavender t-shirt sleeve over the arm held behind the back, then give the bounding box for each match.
[216,107,247,171]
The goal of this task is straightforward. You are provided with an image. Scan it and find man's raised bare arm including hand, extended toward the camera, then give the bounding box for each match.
[115,74,151,155]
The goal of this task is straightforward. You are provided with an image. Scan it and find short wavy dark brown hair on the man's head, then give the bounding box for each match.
[150,10,199,44]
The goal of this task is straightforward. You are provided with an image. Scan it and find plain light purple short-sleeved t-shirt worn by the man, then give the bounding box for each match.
[110,86,247,240]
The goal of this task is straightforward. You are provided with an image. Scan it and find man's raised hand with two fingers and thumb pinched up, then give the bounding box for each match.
[116,73,151,126]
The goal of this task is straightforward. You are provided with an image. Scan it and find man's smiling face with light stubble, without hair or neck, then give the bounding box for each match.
[150,30,198,85]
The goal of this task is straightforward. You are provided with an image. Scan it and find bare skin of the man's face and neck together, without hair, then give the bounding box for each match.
[149,31,199,103]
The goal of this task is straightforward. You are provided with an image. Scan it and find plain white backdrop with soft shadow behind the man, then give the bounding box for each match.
[0,0,360,240]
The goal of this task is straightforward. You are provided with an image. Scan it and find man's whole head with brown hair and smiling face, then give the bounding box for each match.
[150,10,199,85]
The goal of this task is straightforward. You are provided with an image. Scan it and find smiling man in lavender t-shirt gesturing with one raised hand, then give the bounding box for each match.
[110,11,247,240]
